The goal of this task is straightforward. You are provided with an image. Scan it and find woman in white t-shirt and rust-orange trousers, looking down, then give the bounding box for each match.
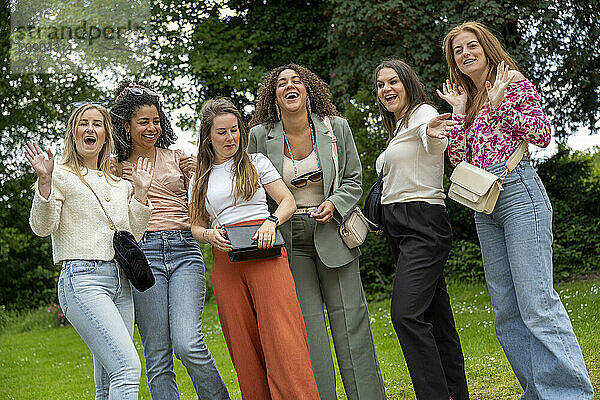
[190,98,319,400]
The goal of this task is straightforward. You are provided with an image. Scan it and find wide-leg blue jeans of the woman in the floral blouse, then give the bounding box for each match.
[475,159,594,400]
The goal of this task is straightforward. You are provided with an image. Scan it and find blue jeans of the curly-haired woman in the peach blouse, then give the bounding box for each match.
[133,231,229,400]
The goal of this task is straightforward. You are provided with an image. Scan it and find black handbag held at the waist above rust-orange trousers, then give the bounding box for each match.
[223,224,284,262]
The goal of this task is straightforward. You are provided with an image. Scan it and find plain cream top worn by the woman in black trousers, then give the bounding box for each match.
[376,104,448,204]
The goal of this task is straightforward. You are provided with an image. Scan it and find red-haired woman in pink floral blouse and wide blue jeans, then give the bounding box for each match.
[438,22,594,400]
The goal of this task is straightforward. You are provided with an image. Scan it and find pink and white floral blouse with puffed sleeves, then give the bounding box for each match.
[448,79,550,168]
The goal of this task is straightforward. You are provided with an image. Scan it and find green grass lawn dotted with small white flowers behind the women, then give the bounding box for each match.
[0,278,600,400]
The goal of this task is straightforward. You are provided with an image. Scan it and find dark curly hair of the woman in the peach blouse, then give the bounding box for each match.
[110,79,177,162]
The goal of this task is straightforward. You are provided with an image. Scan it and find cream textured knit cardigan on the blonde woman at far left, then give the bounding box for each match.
[29,165,152,264]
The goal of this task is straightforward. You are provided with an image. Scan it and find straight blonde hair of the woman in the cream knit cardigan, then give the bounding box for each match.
[60,104,116,181]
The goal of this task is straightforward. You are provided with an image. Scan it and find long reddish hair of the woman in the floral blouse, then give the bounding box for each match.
[444,21,519,128]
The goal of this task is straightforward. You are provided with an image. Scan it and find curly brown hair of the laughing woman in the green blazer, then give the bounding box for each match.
[248,64,341,128]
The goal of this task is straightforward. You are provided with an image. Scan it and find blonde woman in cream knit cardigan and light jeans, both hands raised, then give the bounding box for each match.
[25,104,152,400]
